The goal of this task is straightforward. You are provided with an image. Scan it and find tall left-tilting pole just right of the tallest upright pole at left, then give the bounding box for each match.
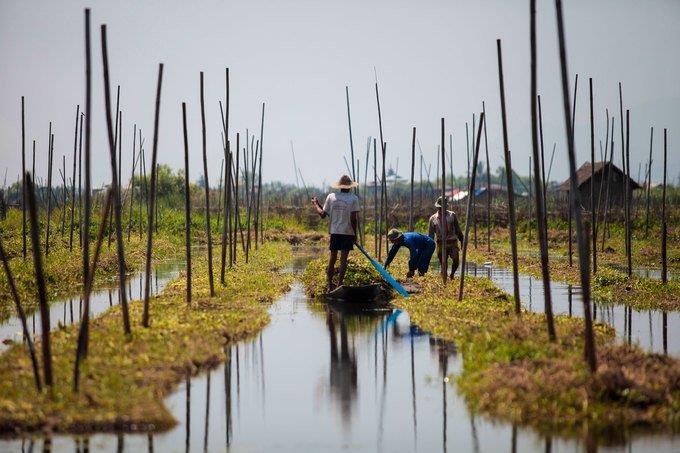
[100,24,132,336]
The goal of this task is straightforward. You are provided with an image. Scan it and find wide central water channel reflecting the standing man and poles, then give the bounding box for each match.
[5,284,680,452]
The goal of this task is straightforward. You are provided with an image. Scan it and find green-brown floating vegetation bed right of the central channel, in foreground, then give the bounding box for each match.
[396,277,680,435]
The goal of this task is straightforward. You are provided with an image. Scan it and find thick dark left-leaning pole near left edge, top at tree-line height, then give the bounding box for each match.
[25,175,54,389]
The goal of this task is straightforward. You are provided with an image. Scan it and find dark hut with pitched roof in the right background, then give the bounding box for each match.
[557,162,642,210]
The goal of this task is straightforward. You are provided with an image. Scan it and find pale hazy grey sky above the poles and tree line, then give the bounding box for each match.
[0,0,680,186]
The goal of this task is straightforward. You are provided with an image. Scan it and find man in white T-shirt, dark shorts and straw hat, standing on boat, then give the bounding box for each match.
[312,175,359,291]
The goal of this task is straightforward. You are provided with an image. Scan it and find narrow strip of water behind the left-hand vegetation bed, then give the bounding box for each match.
[0,262,184,351]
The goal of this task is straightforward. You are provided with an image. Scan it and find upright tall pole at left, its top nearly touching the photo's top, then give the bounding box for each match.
[82,8,92,294]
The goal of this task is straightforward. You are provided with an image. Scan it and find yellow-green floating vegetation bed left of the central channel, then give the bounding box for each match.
[0,243,292,433]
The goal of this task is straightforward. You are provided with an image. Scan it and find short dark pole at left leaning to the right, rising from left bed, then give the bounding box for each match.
[73,188,113,393]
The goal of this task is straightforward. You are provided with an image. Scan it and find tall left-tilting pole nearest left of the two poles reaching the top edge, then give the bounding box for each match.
[494,39,520,313]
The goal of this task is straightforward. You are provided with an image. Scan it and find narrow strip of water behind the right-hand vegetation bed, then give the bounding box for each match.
[466,263,680,355]
